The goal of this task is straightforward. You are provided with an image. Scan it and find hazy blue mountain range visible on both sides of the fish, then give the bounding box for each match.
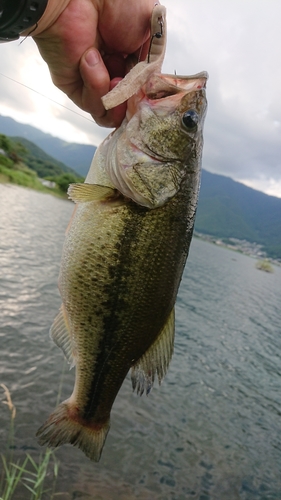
[0,115,281,259]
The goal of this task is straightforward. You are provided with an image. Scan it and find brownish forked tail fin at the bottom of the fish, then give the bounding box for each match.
[36,399,110,462]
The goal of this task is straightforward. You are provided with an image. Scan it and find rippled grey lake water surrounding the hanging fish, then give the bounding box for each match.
[0,185,281,500]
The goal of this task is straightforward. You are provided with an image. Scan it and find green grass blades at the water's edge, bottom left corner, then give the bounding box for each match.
[0,384,59,500]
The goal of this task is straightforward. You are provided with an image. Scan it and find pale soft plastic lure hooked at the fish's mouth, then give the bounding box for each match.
[102,5,167,109]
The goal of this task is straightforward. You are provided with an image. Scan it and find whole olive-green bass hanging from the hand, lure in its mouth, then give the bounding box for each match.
[37,6,207,462]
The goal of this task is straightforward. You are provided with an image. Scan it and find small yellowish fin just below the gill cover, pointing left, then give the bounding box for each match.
[67,183,115,203]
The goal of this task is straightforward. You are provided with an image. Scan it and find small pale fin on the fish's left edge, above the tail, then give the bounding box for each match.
[50,305,76,368]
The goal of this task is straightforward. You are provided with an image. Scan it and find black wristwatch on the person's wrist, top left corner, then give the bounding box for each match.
[0,0,48,43]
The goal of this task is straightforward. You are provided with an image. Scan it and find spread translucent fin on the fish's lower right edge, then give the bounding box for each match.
[131,309,175,396]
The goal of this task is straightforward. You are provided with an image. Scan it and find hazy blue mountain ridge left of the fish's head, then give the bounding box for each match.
[0,115,96,177]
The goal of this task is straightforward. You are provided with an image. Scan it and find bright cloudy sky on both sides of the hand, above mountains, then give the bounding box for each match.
[0,0,281,198]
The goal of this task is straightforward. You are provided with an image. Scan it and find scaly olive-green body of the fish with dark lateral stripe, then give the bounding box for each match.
[60,182,196,421]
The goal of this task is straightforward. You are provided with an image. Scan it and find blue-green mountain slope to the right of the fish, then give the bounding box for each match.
[195,170,281,258]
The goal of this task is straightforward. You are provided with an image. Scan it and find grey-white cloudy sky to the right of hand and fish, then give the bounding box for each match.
[166,0,281,196]
